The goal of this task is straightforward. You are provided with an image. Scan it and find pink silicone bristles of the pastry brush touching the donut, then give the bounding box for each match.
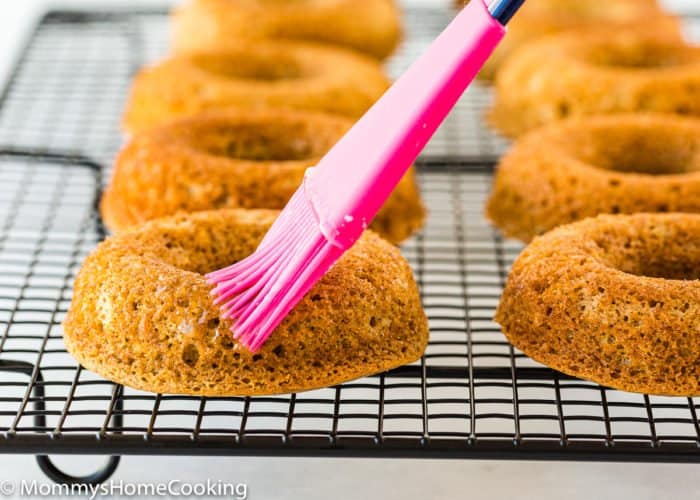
[207,186,343,352]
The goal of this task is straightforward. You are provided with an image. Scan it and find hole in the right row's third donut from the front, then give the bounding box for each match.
[582,40,697,70]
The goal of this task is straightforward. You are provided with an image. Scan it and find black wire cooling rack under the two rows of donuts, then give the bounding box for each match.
[0,0,700,482]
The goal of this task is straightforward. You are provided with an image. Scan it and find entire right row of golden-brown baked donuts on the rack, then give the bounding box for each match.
[468,0,700,396]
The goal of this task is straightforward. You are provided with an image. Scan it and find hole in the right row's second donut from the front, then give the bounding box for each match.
[568,125,700,176]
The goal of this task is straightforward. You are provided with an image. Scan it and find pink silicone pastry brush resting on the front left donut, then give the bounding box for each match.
[207,0,523,351]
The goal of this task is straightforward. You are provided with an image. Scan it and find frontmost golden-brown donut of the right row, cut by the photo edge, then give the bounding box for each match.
[496,214,700,396]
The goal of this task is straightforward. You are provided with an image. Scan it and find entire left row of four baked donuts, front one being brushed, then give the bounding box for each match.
[64,0,428,396]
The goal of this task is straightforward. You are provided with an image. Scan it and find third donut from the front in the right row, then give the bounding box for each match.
[490,30,700,136]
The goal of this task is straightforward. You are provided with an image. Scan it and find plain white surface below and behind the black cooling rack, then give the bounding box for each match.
[0,0,700,500]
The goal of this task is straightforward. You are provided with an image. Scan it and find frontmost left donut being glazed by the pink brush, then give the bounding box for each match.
[64,210,428,396]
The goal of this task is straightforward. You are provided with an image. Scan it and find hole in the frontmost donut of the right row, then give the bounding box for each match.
[596,223,700,280]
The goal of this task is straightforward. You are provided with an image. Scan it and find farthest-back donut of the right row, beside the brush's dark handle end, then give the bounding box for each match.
[457,0,681,80]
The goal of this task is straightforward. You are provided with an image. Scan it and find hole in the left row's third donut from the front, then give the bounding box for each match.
[192,52,307,82]
